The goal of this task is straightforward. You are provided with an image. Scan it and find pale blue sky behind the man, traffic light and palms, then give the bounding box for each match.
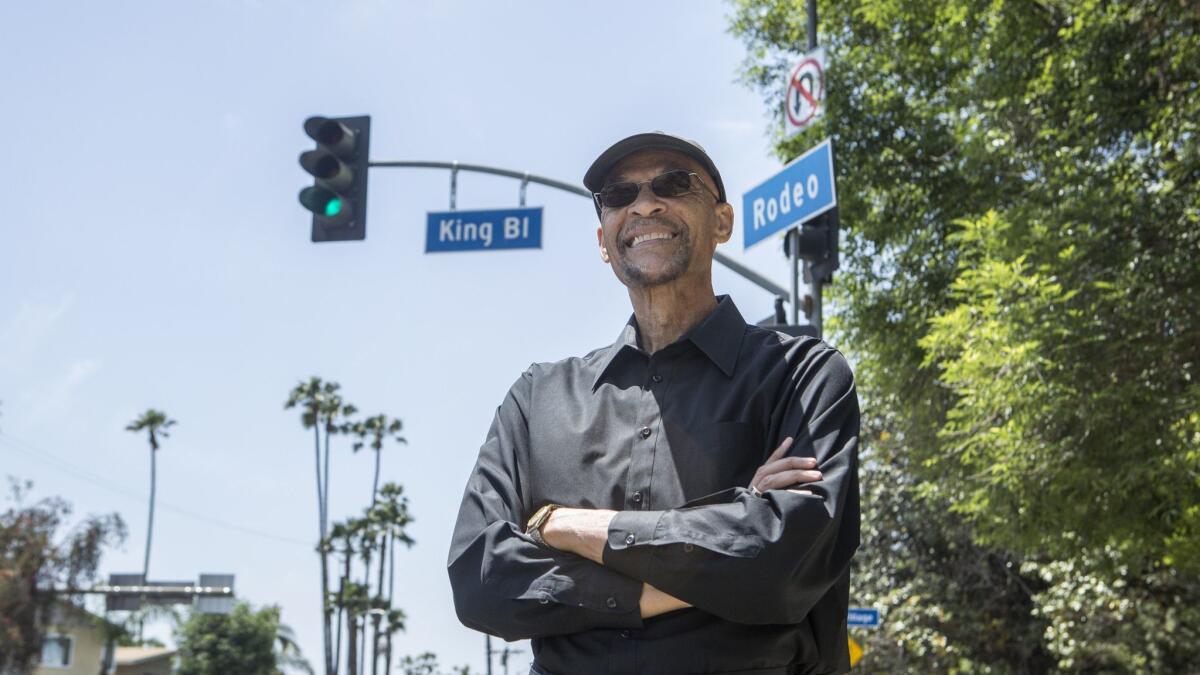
[0,0,806,671]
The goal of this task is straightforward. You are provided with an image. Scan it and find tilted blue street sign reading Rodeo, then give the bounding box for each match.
[742,139,838,249]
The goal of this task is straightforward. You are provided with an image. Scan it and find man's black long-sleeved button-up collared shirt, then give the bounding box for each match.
[449,297,859,675]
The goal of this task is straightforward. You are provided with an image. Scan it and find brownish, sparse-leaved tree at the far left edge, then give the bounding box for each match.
[0,479,126,673]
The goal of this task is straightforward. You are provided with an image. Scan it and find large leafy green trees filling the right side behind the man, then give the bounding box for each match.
[732,0,1200,671]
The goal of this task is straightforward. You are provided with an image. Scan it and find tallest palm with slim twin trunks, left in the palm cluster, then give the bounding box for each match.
[283,376,355,674]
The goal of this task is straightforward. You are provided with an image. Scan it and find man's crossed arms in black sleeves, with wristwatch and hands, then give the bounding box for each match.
[448,350,858,640]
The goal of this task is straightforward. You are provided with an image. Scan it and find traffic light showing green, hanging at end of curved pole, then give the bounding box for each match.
[300,115,371,241]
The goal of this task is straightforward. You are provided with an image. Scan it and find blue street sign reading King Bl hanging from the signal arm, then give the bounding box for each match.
[425,207,541,253]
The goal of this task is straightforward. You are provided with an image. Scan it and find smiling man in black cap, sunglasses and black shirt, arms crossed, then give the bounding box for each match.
[449,133,858,675]
